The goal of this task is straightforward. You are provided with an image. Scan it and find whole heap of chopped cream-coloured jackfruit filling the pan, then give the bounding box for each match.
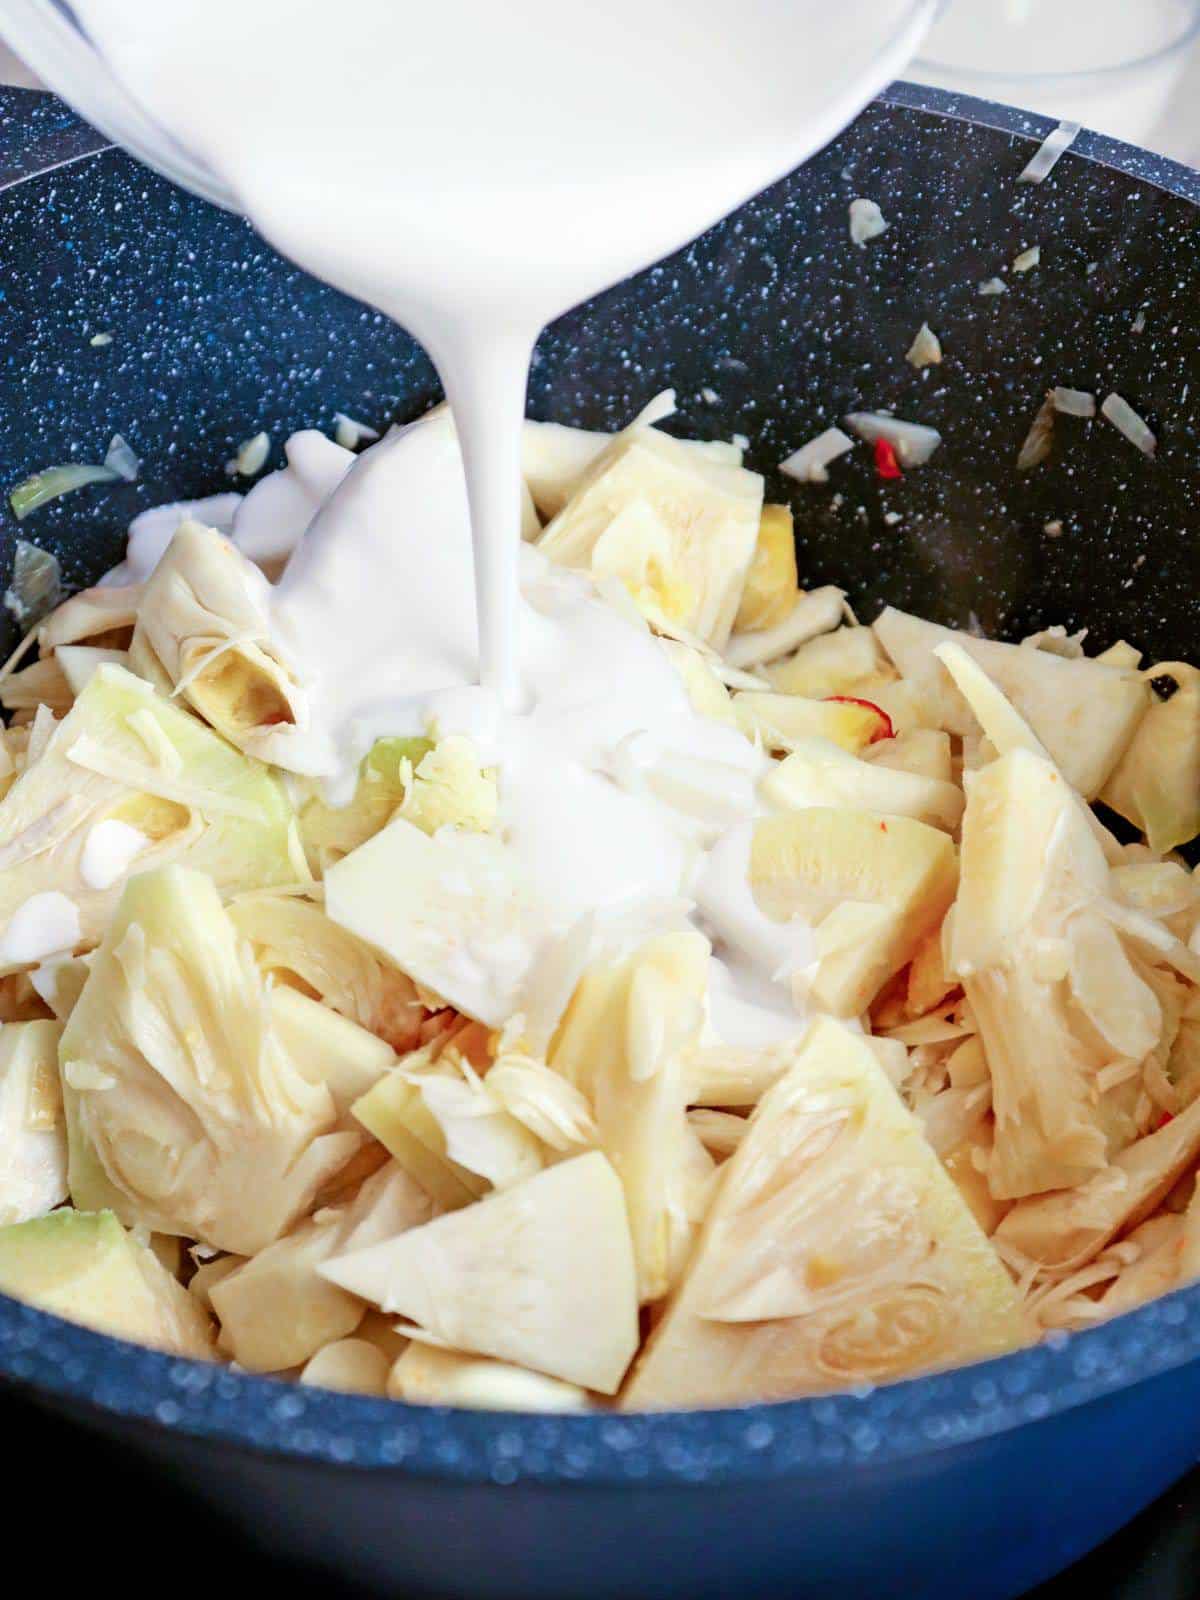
[0,403,1200,1410]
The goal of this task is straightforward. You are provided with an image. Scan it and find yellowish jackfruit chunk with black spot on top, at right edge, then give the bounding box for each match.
[1101,661,1200,854]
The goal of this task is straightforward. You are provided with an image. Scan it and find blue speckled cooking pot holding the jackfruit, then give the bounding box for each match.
[0,85,1200,1600]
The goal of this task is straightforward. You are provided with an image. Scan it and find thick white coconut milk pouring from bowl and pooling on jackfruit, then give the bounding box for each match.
[75,0,936,1040]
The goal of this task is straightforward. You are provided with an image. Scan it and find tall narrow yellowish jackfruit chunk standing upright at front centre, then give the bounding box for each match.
[549,933,709,1302]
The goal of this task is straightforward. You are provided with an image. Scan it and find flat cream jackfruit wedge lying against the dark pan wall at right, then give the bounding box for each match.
[875,606,1149,800]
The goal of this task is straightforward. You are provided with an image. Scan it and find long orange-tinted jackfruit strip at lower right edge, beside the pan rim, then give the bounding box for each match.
[995,1101,1200,1272]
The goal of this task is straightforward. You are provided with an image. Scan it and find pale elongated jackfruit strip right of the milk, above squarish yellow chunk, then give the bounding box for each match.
[760,739,963,832]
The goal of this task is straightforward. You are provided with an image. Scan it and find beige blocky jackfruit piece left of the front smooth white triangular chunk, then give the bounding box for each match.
[208,1163,435,1373]
